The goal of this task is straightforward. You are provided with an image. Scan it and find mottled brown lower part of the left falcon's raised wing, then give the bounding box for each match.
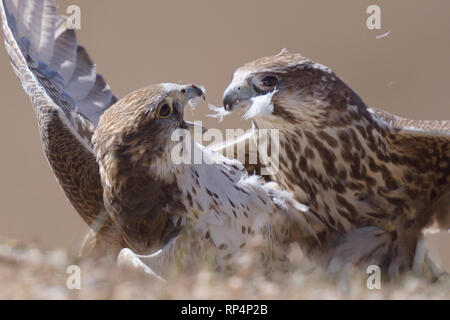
[37,104,121,255]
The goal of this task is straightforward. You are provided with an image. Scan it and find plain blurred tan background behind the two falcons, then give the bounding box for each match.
[0,0,450,270]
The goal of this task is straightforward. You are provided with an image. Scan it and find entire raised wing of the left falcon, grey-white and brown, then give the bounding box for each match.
[0,0,117,246]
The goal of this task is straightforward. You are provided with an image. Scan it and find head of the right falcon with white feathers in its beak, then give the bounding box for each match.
[223,50,361,127]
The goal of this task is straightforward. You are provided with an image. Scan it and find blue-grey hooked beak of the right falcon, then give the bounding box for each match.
[223,82,258,112]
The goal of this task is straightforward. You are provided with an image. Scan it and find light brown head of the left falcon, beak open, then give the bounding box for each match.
[93,83,205,159]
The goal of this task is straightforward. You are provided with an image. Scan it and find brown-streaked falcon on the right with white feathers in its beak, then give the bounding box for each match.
[223,50,450,276]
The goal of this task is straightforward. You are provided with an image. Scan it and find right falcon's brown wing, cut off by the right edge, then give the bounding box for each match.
[370,109,450,229]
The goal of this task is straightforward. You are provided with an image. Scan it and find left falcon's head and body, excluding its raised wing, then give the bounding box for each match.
[92,83,320,274]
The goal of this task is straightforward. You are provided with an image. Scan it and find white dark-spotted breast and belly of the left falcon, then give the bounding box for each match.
[128,142,326,276]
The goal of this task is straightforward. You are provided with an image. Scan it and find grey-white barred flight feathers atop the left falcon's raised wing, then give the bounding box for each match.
[0,0,116,138]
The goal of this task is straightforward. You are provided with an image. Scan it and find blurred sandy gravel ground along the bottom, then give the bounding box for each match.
[0,241,450,299]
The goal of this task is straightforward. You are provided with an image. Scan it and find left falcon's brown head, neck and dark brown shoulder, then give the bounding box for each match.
[92,84,205,253]
